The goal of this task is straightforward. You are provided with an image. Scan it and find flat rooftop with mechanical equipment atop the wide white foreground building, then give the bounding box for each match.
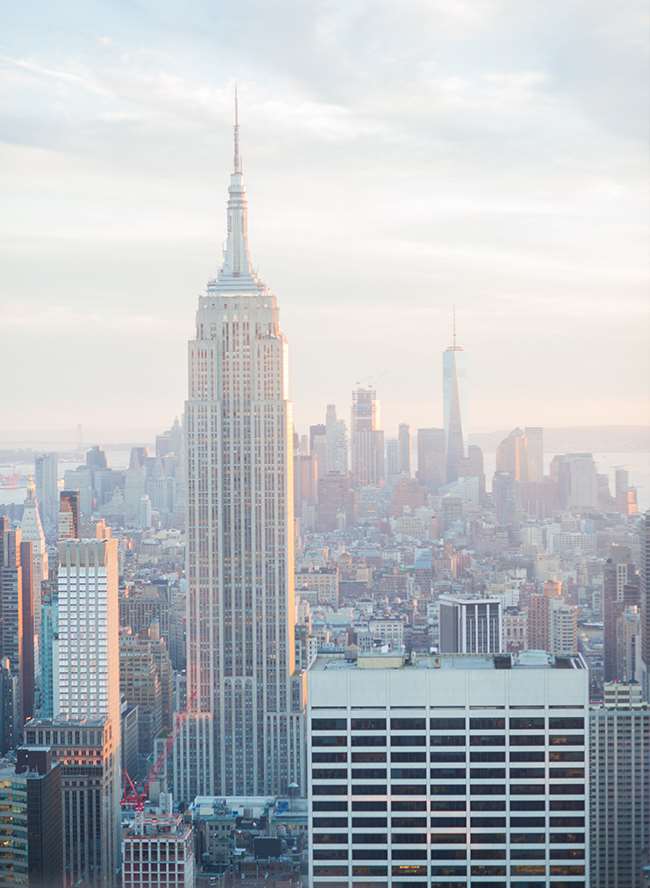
[311,651,587,672]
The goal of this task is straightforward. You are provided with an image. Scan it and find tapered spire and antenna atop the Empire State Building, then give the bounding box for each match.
[213,88,265,293]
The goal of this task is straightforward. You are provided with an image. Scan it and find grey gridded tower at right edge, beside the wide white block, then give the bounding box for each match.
[589,682,650,888]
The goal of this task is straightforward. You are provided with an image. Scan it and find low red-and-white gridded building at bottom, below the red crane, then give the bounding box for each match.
[122,799,194,888]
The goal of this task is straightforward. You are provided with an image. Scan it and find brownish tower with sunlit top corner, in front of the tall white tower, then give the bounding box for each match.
[24,717,121,888]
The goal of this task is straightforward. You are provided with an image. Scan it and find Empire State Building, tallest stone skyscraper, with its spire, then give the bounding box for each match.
[185,97,304,795]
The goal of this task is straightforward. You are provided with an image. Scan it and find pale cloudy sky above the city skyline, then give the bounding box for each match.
[0,0,650,440]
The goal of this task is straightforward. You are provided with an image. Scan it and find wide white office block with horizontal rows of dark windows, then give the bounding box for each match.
[308,651,590,888]
